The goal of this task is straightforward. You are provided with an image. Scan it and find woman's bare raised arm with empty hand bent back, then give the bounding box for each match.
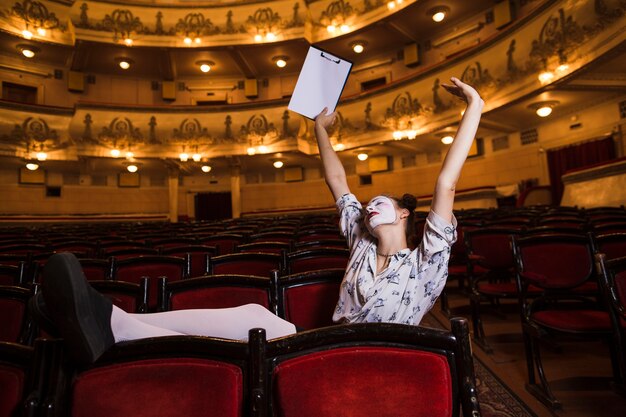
[431,77,484,221]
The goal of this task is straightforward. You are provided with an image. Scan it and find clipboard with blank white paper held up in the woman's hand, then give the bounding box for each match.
[287,46,352,119]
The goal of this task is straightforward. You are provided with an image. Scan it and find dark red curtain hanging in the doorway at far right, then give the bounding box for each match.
[547,136,615,204]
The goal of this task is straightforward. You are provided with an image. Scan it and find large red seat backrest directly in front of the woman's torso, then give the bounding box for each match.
[250,318,480,417]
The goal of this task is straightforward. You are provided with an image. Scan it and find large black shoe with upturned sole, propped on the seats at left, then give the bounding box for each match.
[41,252,115,364]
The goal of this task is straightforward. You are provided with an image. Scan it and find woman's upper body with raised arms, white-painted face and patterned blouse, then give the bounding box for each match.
[315,78,484,325]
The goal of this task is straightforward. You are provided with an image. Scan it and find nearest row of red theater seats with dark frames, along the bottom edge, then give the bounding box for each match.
[0,319,481,417]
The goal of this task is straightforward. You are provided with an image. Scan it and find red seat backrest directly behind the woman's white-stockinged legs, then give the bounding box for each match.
[158,274,272,311]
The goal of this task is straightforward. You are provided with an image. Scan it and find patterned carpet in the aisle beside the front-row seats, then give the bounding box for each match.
[421,313,536,417]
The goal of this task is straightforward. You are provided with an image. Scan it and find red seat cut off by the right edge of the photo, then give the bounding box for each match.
[596,253,626,392]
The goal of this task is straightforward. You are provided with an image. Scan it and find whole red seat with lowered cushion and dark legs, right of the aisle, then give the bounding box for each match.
[513,234,619,410]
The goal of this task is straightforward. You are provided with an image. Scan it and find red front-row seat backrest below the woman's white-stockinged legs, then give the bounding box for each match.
[44,336,249,417]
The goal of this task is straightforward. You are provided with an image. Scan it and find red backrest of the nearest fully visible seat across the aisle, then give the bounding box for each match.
[512,234,595,290]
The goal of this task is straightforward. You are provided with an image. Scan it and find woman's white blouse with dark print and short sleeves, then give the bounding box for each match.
[333,194,457,325]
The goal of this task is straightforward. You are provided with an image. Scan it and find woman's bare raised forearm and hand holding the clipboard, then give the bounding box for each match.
[315,108,350,201]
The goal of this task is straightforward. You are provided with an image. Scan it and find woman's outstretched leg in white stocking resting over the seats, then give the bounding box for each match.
[127,304,296,340]
